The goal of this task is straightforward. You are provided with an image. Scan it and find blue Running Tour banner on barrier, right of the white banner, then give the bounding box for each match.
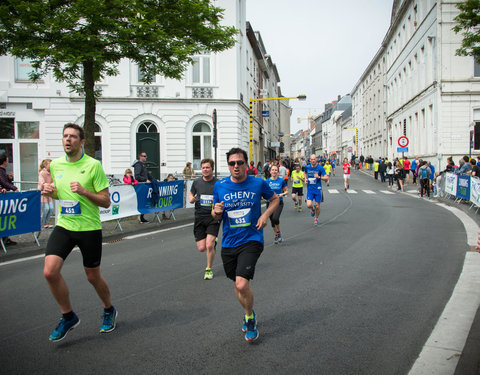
[135,180,183,214]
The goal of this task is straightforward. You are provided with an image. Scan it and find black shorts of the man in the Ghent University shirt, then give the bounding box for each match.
[222,241,263,281]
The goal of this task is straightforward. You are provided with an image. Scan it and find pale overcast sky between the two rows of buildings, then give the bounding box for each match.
[247,0,393,133]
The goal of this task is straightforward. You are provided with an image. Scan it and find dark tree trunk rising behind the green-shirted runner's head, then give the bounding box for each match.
[83,61,96,158]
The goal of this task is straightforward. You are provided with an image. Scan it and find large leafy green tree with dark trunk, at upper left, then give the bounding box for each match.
[0,0,237,156]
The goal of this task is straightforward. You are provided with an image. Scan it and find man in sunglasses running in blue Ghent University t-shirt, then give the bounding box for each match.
[212,148,279,341]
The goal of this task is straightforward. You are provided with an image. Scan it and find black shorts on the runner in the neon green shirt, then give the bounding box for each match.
[45,225,102,268]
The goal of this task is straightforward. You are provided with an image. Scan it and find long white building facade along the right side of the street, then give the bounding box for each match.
[352,0,480,169]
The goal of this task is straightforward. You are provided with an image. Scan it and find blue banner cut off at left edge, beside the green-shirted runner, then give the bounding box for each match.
[0,190,41,237]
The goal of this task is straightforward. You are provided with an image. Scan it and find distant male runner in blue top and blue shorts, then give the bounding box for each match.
[305,154,329,226]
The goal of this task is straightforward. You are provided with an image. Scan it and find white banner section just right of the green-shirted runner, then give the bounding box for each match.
[100,185,139,221]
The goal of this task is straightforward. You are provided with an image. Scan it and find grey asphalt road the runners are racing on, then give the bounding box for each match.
[0,173,467,374]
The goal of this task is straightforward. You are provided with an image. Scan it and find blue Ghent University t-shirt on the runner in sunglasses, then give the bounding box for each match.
[213,176,275,247]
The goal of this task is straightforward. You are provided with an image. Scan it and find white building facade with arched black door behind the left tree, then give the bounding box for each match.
[0,0,288,188]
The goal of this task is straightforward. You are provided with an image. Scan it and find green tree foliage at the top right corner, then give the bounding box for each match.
[453,0,480,64]
